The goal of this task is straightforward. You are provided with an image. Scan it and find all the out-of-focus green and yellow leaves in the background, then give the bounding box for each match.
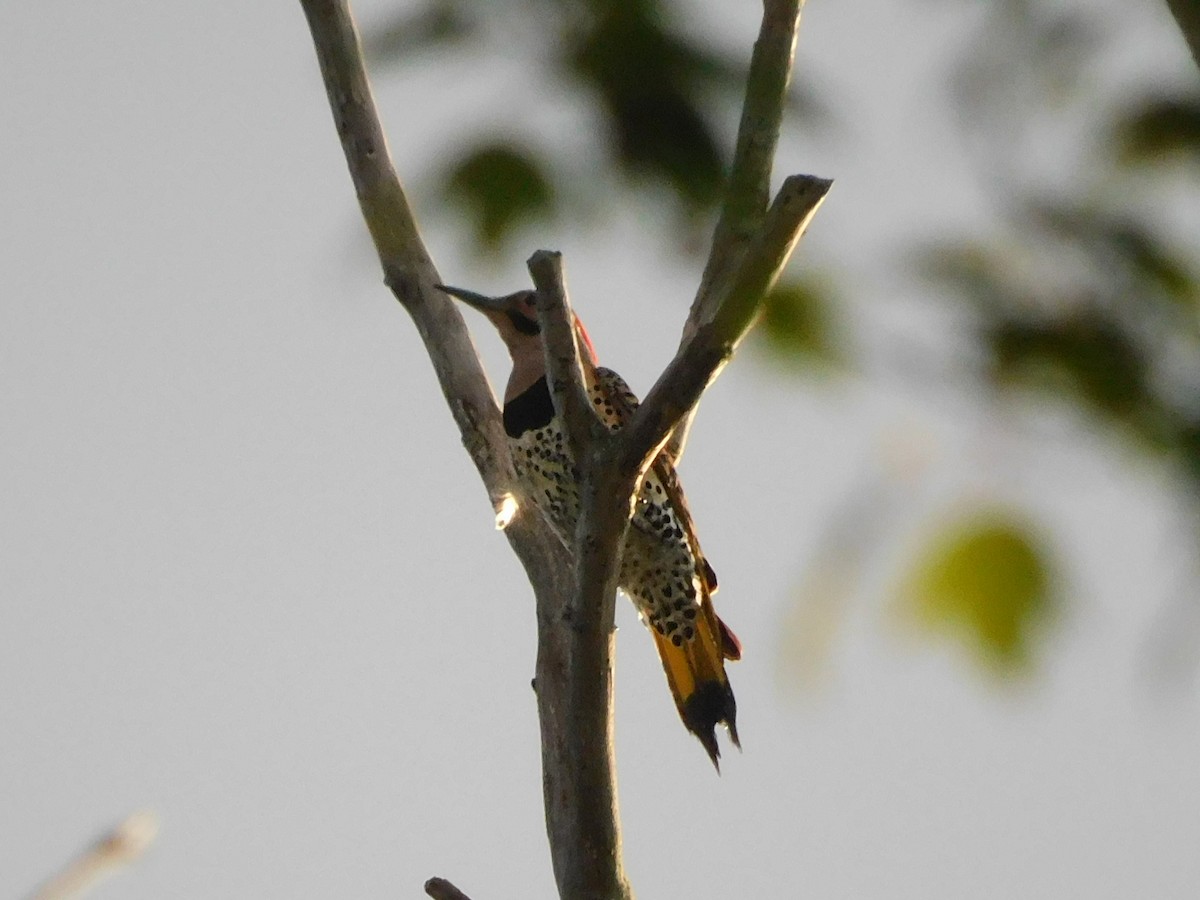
[365,0,1200,672]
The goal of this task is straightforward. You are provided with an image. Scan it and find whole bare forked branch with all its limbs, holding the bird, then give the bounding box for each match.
[301,0,829,900]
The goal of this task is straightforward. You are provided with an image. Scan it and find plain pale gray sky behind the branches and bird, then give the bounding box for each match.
[0,0,1200,900]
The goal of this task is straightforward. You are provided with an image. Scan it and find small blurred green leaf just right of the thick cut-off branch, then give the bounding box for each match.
[757,272,839,366]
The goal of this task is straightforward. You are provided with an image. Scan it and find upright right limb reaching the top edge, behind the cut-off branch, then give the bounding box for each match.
[666,0,804,460]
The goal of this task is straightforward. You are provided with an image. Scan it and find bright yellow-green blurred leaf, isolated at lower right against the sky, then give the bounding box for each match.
[904,509,1054,668]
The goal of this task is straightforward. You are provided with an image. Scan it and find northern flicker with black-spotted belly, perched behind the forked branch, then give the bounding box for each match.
[438,284,742,766]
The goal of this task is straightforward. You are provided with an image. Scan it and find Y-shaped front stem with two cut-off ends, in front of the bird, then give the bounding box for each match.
[529,164,832,898]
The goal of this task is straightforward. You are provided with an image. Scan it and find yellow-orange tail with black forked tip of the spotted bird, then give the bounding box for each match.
[650,598,742,772]
